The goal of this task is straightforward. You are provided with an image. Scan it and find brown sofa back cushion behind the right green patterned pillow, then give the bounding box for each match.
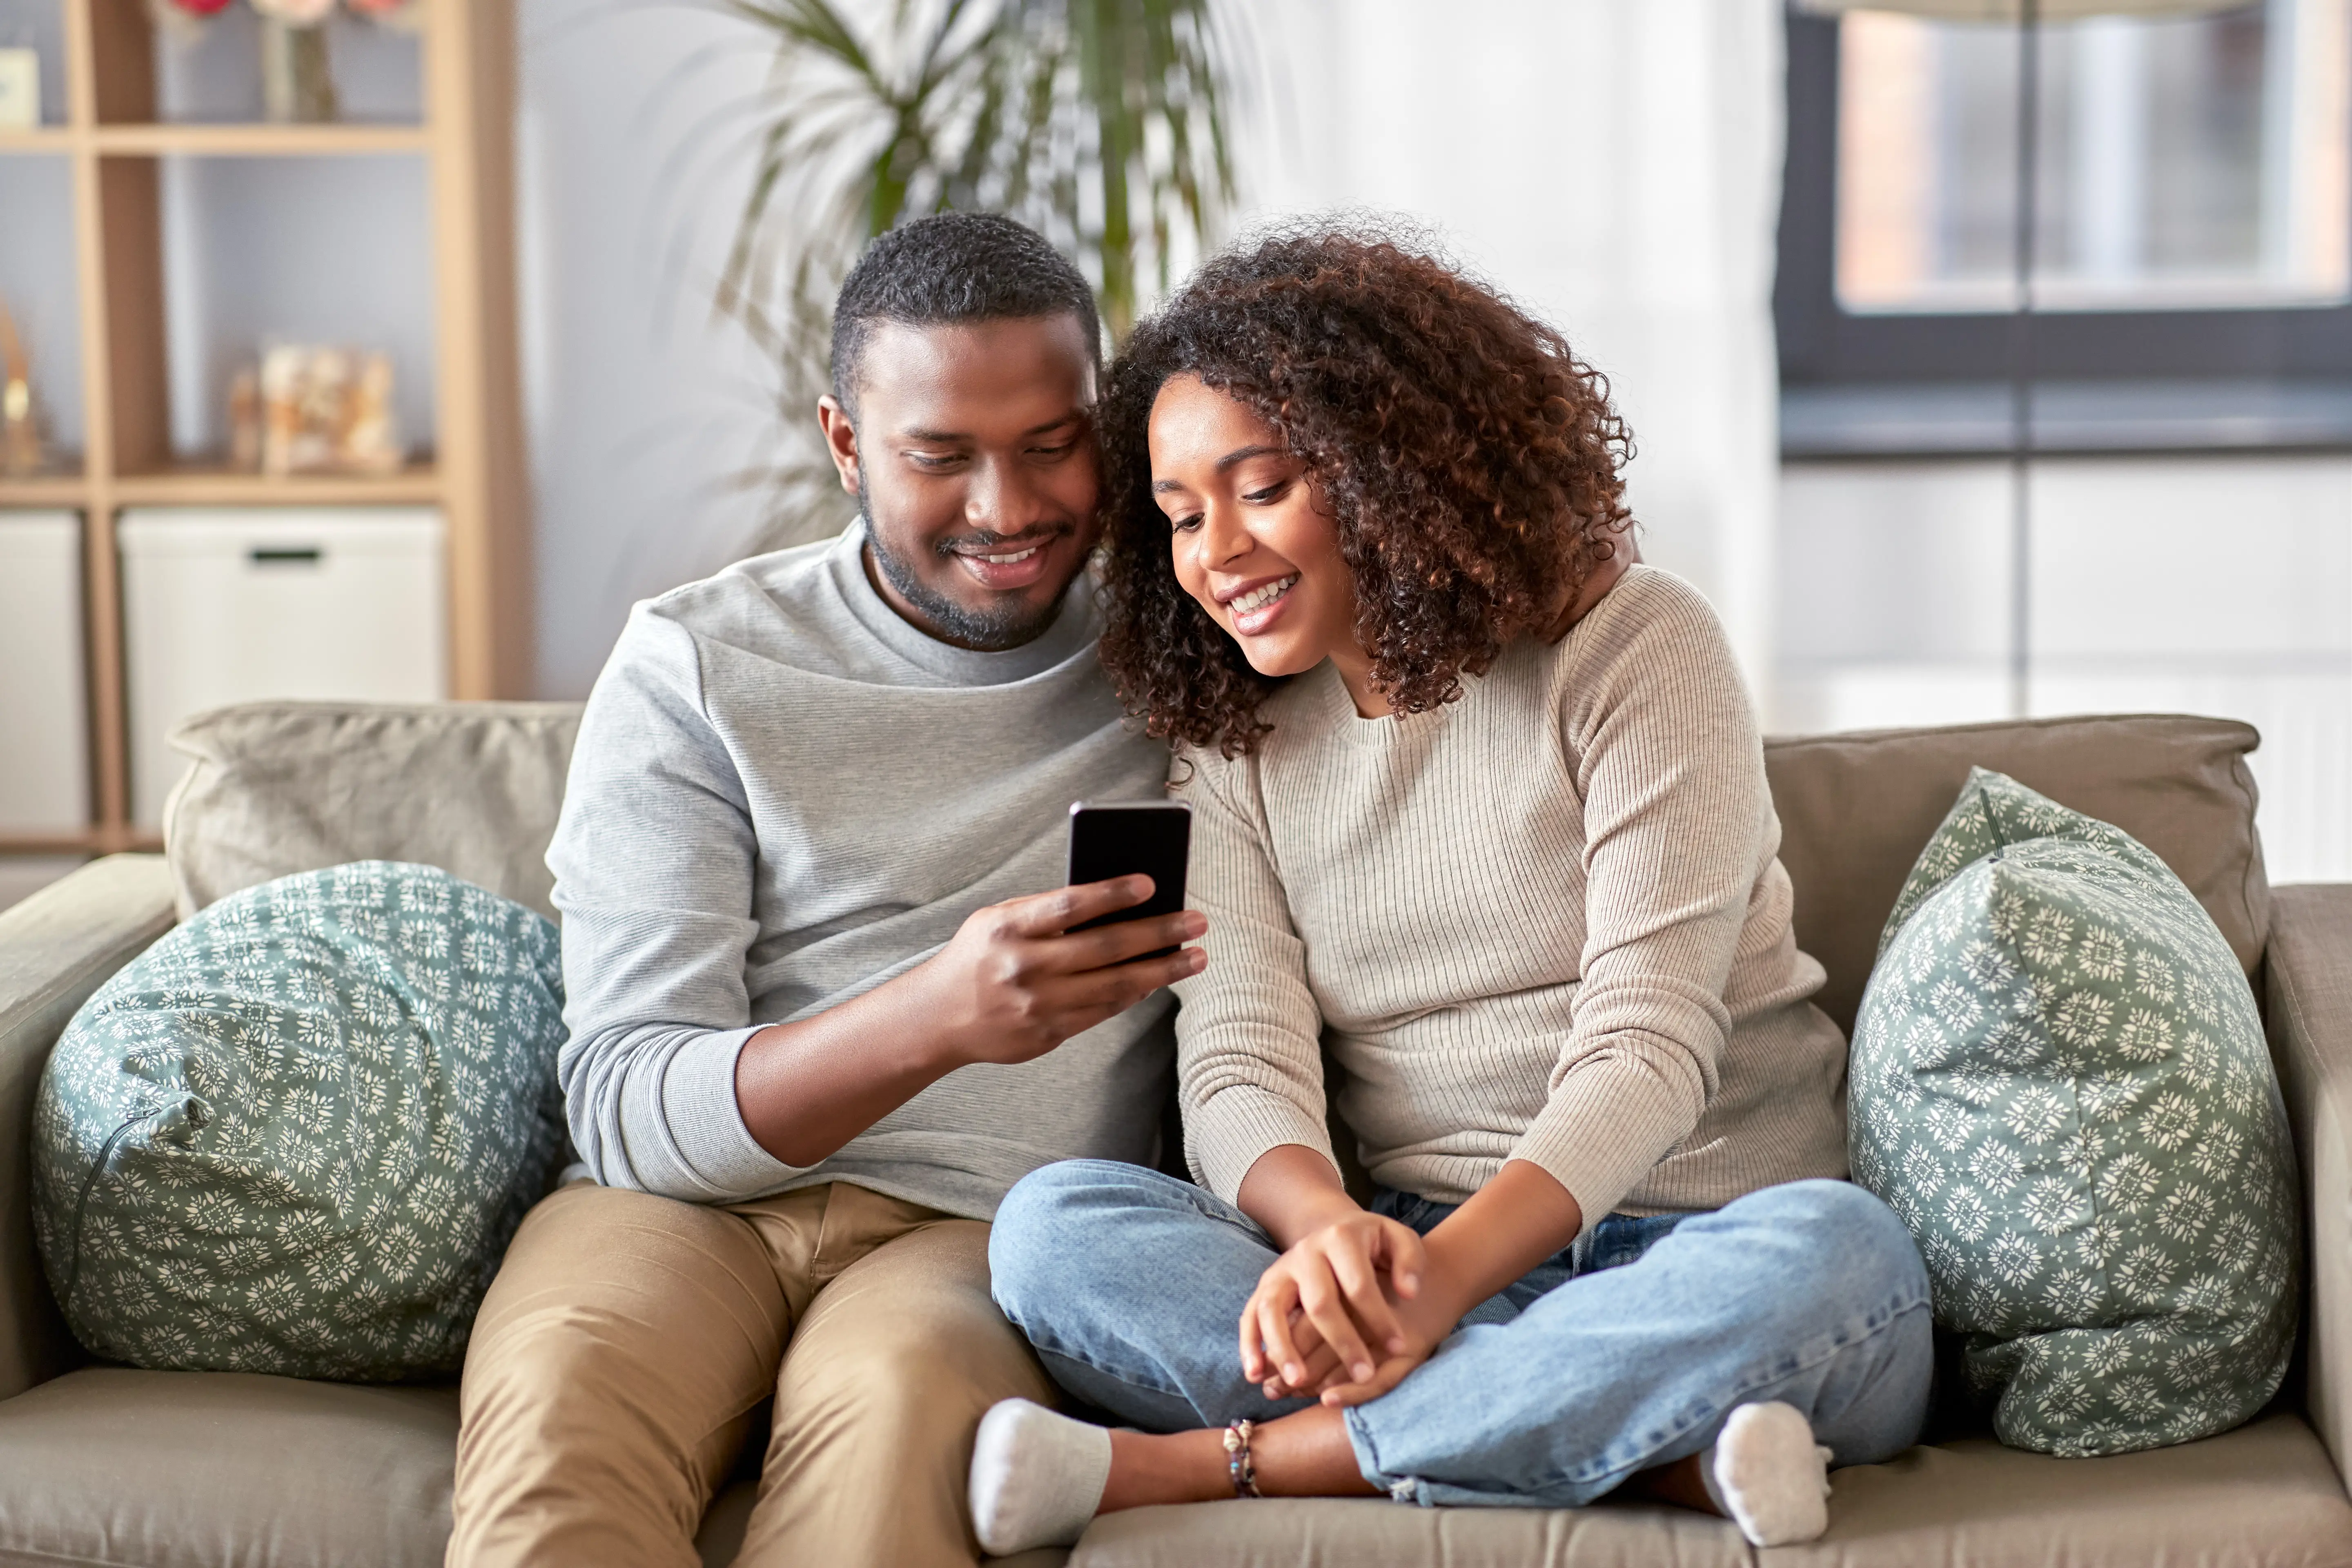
[1764,715,2270,1032]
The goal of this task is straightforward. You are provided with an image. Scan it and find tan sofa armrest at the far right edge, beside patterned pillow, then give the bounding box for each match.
[2265,882,2352,1486]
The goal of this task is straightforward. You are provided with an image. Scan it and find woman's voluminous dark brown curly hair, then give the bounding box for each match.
[1101,226,1632,757]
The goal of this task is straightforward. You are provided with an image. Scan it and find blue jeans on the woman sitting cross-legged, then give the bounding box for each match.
[988,1159,1933,1507]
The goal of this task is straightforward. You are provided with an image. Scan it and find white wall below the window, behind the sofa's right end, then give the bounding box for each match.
[1771,456,2352,882]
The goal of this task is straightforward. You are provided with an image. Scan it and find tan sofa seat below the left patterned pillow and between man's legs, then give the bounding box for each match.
[0,1366,771,1568]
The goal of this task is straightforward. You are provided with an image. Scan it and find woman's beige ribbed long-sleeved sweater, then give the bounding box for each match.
[1174,566,1846,1225]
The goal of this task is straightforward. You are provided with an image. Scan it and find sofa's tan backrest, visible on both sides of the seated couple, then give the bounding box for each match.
[165,703,2270,1030]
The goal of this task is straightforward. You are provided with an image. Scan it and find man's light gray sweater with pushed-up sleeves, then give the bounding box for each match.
[548,527,1174,1218]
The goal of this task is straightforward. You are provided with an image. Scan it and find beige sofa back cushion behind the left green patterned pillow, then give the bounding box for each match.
[162,703,581,919]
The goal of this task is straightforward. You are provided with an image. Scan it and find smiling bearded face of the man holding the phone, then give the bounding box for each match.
[818,315,1101,649]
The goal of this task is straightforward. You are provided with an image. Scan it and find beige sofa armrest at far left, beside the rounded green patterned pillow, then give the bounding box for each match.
[0,856,174,1399]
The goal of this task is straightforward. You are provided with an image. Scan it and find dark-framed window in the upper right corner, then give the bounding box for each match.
[1773,0,2352,421]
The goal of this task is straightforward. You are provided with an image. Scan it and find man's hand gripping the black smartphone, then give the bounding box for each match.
[927,877,1209,1062]
